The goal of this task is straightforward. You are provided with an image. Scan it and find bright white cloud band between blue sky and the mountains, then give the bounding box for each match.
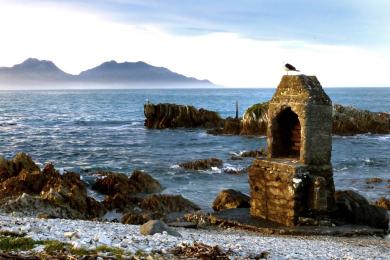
[0,3,390,87]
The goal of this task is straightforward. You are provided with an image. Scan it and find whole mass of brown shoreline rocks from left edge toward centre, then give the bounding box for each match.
[0,154,199,224]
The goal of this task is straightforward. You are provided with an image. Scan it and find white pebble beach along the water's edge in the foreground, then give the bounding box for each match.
[0,213,390,259]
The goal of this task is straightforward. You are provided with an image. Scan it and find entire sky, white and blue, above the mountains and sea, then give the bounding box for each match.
[0,0,390,87]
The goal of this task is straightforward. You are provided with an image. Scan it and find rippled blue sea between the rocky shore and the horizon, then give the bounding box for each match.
[0,88,390,209]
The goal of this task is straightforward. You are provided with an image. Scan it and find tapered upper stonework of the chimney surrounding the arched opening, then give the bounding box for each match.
[267,75,332,164]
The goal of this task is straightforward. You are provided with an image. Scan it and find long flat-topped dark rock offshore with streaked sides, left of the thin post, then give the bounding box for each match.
[144,104,224,129]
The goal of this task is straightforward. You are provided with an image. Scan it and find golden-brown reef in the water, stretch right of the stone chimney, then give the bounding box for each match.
[333,104,390,135]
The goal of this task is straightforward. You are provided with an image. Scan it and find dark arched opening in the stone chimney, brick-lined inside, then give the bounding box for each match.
[272,107,301,158]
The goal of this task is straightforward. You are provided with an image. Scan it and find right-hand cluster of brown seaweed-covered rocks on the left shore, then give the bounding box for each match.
[93,171,200,225]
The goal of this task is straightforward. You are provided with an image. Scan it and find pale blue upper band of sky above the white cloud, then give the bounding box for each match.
[47,0,390,45]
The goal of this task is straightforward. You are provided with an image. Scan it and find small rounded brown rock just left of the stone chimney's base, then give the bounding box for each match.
[213,189,250,211]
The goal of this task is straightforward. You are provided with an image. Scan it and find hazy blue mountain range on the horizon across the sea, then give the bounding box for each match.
[0,58,212,85]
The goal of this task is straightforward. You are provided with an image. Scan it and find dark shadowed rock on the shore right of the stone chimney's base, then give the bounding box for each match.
[335,190,389,230]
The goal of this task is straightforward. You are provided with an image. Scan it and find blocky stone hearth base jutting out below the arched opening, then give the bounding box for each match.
[249,159,309,226]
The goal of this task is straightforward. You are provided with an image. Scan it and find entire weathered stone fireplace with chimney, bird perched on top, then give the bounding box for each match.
[249,75,334,226]
